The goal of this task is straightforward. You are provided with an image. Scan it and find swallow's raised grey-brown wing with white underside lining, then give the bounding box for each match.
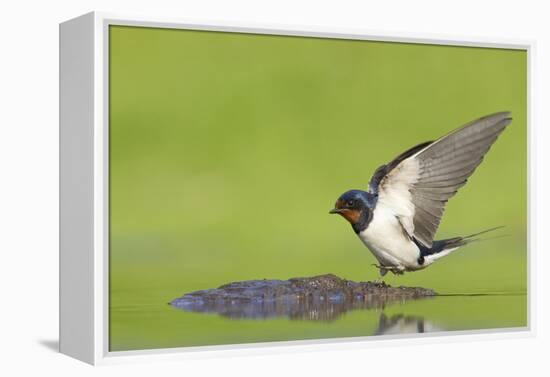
[369,112,512,247]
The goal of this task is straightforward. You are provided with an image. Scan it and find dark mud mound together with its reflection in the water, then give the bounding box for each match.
[170,275,434,321]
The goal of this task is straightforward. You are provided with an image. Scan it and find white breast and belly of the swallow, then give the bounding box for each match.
[359,202,420,270]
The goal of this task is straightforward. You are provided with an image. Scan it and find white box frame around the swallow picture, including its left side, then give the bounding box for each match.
[60,12,535,364]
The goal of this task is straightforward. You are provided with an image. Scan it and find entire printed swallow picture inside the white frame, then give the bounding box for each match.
[108,26,528,351]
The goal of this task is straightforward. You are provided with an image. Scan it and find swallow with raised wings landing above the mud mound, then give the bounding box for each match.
[329,111,512,278]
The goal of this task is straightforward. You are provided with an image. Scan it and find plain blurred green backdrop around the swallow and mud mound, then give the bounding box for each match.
[109,26,527,351]
